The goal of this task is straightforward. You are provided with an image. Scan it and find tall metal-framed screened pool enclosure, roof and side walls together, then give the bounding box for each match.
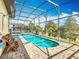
[10,0,79,45]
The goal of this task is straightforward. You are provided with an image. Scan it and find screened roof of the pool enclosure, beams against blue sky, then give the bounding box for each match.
[15,0,79,21]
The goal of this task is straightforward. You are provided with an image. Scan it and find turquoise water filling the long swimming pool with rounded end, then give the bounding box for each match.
[21,34,59,48]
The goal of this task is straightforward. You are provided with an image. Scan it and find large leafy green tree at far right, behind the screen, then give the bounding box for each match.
[60,17,78,41]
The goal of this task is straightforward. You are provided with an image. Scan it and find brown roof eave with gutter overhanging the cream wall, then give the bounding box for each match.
[3,0,15,17]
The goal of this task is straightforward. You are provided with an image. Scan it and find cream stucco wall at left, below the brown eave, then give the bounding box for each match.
[0,0,9,34]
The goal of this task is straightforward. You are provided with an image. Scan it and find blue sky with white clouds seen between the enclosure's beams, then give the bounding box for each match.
[15,0,79,26]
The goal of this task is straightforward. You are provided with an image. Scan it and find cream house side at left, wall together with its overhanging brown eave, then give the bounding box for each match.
[0,0,14,34]
